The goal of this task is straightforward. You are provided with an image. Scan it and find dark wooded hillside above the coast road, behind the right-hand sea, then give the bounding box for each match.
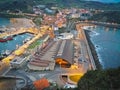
[90,11,120,24]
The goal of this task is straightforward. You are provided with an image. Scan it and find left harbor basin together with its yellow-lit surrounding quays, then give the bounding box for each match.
[0,19,49,75]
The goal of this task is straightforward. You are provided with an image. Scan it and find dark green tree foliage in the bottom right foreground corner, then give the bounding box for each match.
[78,68,120,90]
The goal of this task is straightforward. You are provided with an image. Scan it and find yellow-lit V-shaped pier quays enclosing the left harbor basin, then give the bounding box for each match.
[0,26,52,75]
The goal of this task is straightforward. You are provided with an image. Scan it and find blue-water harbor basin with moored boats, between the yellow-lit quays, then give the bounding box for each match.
[0,33,33,57]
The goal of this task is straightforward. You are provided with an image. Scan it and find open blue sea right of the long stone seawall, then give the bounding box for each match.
[90,26,120,68]
